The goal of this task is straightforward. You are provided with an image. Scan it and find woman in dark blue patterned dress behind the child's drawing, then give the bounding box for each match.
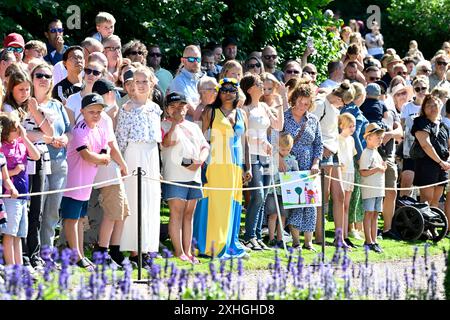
[279,83,323,251]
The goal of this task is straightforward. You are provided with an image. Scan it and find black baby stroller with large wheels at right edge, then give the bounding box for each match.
[392,196,448,242]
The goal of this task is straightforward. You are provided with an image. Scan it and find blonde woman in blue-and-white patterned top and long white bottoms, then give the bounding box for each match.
[116,67,162,263]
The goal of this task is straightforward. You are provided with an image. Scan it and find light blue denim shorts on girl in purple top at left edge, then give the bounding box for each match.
[0,198,28,238]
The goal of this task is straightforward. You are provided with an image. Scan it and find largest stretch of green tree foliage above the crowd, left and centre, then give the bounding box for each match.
[0,0,340,79]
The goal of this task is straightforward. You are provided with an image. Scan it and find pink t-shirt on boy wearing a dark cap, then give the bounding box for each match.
[64,120,108,201]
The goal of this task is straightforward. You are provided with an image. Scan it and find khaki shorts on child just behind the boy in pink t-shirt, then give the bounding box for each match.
[98,184,130,220]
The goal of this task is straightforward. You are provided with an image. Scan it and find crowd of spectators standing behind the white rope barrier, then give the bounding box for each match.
[0,12,450,269]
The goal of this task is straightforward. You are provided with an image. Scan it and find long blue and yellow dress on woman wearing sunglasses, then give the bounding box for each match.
[193,108,245,259]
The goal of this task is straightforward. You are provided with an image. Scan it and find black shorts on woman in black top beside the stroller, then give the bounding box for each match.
[414,157,448,187]
